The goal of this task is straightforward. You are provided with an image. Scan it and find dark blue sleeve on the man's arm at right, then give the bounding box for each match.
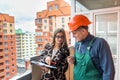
[99,39,115,80]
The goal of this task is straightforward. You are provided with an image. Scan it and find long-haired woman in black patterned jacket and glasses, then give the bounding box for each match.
[40,28,70,80]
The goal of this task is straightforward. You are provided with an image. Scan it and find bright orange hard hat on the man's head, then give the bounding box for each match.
[68,14,91,31]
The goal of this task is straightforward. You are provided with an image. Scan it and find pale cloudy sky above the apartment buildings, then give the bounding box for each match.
[0,0,69,32]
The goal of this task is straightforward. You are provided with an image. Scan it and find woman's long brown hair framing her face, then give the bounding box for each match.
[52,28,67,47]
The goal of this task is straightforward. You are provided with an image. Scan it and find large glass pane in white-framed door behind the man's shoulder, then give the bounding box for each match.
[95,13,117,55]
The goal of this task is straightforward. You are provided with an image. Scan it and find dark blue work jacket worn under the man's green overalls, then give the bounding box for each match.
[75,33,115,80]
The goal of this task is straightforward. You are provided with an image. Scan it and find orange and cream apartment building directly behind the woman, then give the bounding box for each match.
[35,0,71,55]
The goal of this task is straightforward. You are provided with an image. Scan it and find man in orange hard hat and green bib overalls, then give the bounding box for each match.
[67,15,115,80]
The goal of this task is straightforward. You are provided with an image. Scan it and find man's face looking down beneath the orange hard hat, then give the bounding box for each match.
[72,28,84,42]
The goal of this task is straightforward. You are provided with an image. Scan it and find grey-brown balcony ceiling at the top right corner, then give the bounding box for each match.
[77,0,120,10]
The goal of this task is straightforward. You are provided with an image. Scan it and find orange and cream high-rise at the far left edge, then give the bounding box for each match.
[0,13,17,80]
